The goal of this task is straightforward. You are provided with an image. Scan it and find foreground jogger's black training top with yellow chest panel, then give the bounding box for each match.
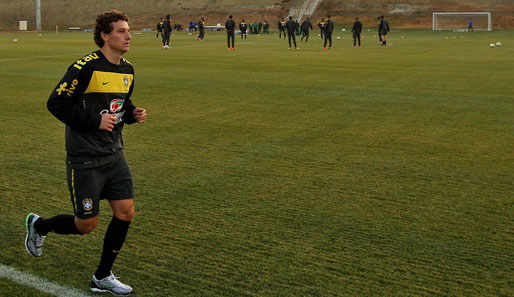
[47,50,136,162]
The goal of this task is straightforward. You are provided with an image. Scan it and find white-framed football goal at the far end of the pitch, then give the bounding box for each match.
[432,12,493,31]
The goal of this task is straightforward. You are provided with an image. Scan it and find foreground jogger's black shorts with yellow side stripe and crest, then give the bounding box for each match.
[66,154,134,219]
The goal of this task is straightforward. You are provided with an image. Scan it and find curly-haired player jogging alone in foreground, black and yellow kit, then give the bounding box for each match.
[25,10,146,295]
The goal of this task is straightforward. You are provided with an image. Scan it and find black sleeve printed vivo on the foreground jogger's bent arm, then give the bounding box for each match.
[47,64,102,131]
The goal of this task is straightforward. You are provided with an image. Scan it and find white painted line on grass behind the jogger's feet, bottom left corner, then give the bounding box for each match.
[0,264,93,297]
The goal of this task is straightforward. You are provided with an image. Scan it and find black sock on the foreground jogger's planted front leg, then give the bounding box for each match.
[95,216,130,280]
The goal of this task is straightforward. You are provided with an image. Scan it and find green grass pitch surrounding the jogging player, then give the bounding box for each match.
[0,31,514,296]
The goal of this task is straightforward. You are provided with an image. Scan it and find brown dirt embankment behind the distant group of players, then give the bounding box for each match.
[0,0,514,30]
